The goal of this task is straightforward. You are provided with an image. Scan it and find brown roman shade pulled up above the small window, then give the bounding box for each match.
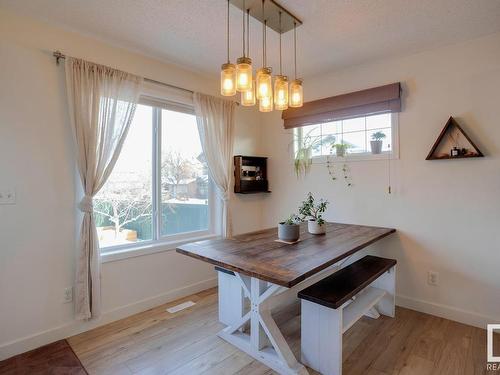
[281,82,401,129]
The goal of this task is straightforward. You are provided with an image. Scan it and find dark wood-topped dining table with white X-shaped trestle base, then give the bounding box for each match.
[177,223,396,374]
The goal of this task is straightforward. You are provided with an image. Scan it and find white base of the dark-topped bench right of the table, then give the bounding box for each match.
[300,266,396,375]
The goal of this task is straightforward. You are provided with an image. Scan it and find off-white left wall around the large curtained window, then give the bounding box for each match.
[0,10,261,360]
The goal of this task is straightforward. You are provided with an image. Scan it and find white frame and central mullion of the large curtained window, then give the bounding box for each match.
[99,95,220,262]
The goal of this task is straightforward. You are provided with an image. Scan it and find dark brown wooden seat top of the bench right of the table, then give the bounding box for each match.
[298,255,396,309]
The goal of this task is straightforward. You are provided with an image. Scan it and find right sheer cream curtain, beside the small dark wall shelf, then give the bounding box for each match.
[193,93,236,238]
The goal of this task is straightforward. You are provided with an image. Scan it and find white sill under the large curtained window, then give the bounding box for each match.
[101,234,220,263]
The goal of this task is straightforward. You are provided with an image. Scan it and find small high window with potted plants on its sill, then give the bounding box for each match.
[294,113,398,160]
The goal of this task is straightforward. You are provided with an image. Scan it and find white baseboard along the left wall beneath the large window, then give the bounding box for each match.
[0,277,217,361]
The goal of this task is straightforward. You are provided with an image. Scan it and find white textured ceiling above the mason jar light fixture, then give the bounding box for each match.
[0,0,500,77]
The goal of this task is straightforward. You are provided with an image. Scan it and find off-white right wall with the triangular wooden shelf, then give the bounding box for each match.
[262,34,500,327]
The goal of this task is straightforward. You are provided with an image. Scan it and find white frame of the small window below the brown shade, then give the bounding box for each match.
[293,112,399,164]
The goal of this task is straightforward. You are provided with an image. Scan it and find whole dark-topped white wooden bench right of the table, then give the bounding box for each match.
[298,255,396,375]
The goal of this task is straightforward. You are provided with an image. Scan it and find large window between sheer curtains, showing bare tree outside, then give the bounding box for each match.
[94,100,213,252]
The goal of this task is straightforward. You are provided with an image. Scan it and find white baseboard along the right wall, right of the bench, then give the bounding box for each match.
[396,295,500,329]
